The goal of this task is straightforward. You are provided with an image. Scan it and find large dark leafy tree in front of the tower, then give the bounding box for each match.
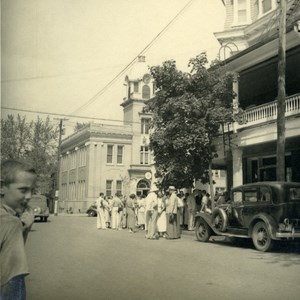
[147,53,234,188]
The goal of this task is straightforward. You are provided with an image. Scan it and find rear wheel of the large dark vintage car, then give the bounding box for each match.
[252,222,274,252]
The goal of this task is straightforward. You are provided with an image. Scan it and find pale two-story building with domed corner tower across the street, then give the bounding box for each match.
[59,56,154,211]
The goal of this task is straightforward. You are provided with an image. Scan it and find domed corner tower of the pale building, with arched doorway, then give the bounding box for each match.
[121,56,155,195]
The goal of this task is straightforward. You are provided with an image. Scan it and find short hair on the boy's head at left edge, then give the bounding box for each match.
[1,159,36,185]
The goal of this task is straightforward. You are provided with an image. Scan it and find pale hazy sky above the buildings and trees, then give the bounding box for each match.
[1,0,225,135]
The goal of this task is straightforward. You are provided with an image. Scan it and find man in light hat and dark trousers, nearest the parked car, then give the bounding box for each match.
[166,186,180,239]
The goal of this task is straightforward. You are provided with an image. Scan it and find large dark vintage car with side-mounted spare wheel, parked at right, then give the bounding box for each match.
[195,182,300,251]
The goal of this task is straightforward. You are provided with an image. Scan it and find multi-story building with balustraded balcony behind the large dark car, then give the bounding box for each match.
[214,0,300,188]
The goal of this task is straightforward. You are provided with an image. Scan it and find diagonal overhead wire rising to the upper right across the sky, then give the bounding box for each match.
[71,0,194,115]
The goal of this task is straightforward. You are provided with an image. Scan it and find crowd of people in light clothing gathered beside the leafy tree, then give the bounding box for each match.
[95,186,216,239]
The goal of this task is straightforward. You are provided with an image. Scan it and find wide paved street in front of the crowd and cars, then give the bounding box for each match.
[26,215,300,300]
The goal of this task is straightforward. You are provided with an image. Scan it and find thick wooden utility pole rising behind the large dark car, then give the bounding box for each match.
[276,0,287,181]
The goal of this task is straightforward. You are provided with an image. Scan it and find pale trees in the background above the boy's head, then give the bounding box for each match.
[1,115,58,192]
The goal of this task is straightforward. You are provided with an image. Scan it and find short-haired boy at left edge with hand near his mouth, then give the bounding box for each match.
[0,160,36,300]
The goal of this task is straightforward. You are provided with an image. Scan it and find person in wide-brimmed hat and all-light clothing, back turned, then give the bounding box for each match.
[145,187,158,239]
